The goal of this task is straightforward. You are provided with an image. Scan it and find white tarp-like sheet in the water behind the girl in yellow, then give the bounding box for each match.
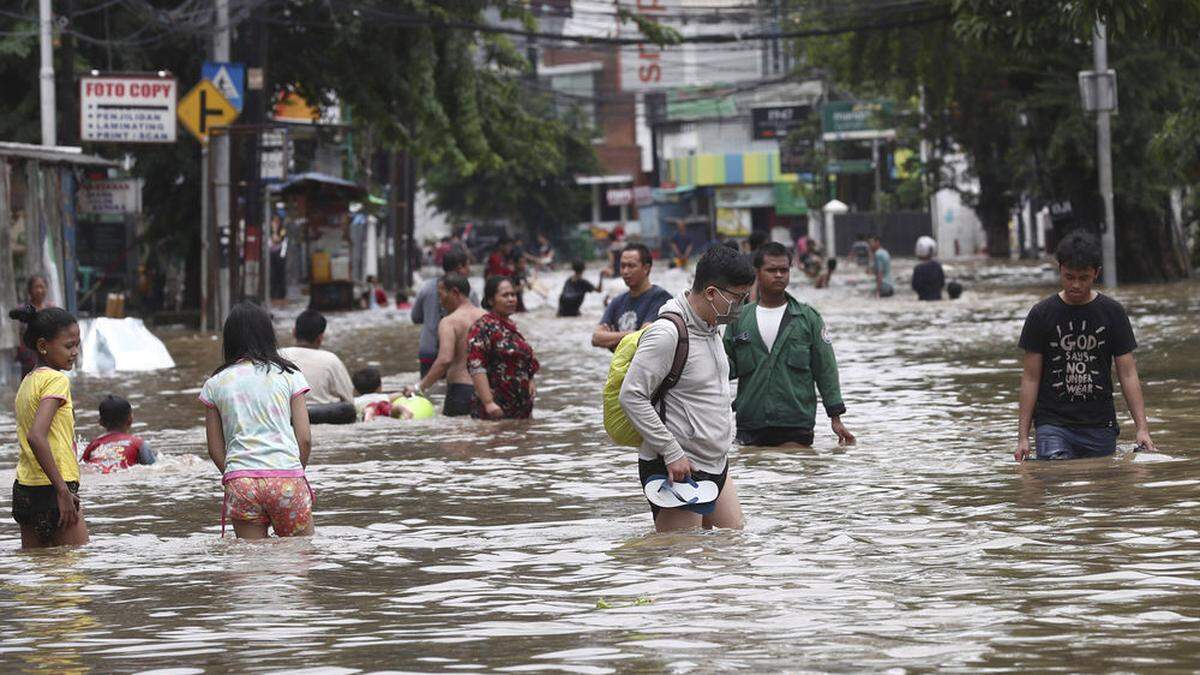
[76,317,175,375]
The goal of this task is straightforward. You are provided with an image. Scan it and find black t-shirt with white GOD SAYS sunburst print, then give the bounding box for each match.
[1020,293,1138,426]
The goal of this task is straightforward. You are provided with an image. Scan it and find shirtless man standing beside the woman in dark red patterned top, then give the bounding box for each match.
[406,273,487,417]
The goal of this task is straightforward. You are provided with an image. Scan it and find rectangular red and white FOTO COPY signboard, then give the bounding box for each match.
[79,73,178,143]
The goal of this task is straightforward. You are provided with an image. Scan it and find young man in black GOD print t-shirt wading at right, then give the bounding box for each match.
[1014,231,1154,461]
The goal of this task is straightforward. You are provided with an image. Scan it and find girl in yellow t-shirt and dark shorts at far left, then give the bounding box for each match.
[8,305,88,549]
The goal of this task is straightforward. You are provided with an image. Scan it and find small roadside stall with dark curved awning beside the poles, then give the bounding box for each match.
[276,173,367,310]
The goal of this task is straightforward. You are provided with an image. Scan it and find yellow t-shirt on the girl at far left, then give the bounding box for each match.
[17,368,79,485]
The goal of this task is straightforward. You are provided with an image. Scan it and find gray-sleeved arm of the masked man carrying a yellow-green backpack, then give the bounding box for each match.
[618,322,691,479]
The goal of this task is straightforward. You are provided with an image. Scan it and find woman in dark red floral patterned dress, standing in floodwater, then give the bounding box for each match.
[467,276,539,419]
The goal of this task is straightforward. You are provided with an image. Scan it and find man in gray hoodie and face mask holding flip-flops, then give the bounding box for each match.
[619,246,755,532]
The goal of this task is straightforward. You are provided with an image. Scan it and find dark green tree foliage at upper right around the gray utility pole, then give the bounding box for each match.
[793,0,1200,280]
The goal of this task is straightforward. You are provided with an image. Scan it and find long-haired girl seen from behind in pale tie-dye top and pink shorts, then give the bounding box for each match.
[200,303,313,539]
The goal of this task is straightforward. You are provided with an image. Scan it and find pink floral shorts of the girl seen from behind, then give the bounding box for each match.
[226,476,312,537]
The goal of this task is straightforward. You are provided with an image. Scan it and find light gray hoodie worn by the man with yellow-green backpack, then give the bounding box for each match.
[619,293,733,473]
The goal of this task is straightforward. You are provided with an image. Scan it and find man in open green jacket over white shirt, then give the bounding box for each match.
[725,243,854,446]
